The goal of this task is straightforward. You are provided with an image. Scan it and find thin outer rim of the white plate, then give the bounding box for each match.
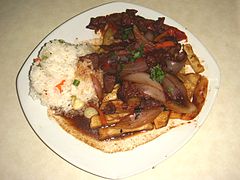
[15,1,221,179]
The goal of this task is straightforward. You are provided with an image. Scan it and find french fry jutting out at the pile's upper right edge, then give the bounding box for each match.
[183,44,204,73]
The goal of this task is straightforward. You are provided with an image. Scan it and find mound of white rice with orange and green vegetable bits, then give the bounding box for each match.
[30,40,100,112]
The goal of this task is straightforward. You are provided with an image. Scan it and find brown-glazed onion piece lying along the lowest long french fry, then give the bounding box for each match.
[115,108,162,129]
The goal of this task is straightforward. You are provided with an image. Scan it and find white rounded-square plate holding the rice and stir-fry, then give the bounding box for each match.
[16,2,220,179]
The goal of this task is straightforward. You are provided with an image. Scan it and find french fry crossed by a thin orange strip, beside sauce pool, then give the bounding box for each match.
[90,113,129,129]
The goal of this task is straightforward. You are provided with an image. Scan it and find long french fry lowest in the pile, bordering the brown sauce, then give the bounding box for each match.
[99,123,154,140]
